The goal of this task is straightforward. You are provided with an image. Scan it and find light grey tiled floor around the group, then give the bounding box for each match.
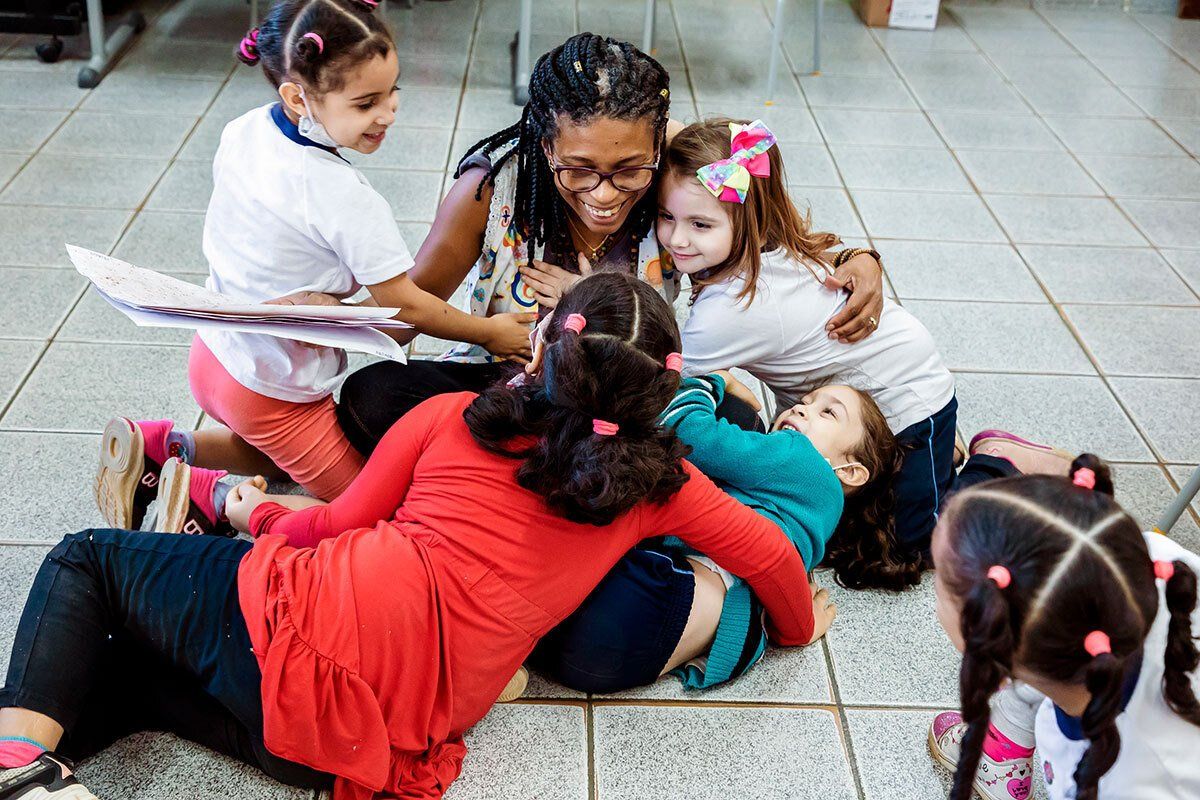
[0,0,1200,800]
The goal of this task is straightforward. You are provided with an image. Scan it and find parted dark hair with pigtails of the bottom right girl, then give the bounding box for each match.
[936,453,1200,800]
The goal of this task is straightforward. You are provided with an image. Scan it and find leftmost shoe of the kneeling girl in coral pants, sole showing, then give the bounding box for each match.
[92,416,174,530]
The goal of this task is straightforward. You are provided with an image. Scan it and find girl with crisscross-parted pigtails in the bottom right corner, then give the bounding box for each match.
[929,455,1200,800]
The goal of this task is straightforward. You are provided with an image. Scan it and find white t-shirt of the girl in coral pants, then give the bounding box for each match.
[200,104,413,403]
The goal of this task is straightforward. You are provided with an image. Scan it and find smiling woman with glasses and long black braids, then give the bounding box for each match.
[338,34,883,453]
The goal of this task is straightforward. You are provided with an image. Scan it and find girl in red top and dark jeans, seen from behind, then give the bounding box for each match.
[0,273,832,800]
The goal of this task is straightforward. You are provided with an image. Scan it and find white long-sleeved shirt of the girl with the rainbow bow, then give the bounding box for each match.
[683,249,954,433]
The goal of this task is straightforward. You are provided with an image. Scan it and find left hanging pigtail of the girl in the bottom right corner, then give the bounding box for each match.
[950,578,1016,800]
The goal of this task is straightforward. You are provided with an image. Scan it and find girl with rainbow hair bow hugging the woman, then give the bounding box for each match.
[658,119,1069,589]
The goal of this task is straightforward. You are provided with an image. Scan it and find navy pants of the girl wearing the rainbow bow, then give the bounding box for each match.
[894,397,1020,557]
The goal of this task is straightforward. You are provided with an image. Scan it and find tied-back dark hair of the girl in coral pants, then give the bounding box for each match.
[235,0,396,92]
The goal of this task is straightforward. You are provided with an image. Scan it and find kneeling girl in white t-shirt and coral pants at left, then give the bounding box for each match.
[88,0,534,530]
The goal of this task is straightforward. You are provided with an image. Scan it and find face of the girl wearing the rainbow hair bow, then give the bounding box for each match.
[656,170,733,275]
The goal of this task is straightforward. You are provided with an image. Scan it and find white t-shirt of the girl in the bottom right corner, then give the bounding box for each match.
[1034,534,1200,800]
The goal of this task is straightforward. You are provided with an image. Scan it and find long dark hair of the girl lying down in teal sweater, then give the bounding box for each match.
[822,389,924,591]
